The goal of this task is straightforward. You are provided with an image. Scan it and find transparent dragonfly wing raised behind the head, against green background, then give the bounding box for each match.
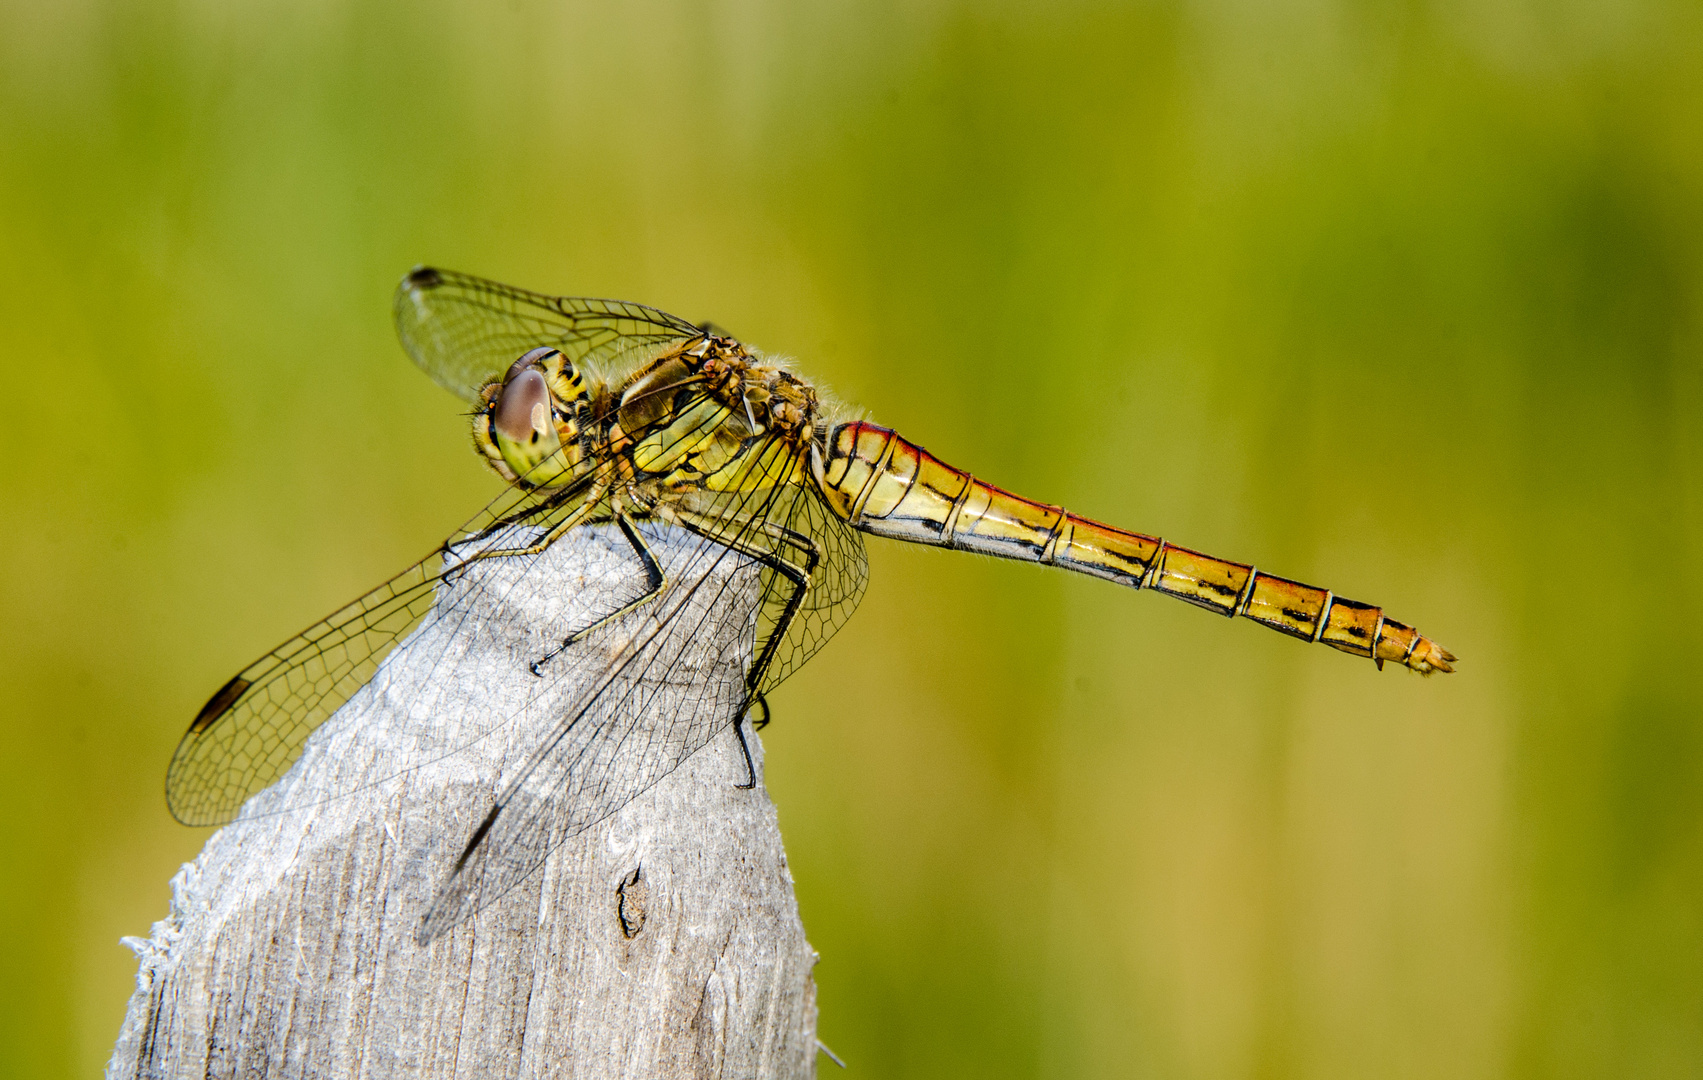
[393,266,702,400]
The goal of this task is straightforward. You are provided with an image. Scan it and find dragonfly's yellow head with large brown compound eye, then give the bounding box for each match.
[473,348,589,487]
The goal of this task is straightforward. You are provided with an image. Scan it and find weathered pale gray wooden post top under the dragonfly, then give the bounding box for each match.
[107,528,817,1080]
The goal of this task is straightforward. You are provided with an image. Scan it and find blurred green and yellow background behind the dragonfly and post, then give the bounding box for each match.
[0,0,1703,1078]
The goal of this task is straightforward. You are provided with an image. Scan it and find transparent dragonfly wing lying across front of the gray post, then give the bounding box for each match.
[419,436,867,942]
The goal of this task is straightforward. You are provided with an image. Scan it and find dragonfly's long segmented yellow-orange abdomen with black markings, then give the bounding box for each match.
[819,421,1454,675]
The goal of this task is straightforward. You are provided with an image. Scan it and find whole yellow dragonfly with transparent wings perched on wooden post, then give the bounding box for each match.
[165,267,1456,942]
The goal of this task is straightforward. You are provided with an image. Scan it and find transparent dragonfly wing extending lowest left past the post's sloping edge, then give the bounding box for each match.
[165,466,606,824]
